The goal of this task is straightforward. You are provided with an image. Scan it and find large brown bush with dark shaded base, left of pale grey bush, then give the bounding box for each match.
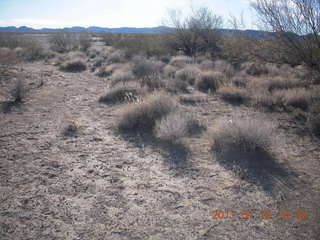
[118,93,177,133]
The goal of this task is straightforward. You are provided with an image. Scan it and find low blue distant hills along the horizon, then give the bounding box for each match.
[0,26,292,39]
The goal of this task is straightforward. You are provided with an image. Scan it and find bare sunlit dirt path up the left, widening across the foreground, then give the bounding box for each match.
[0,63,320,240]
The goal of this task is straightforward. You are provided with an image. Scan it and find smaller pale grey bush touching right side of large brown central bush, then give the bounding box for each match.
[154,111,206,142]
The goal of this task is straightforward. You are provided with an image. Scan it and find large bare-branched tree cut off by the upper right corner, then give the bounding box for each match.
[252,0,320,71]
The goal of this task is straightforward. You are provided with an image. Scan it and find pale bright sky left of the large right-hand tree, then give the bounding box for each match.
[0,0,254,28]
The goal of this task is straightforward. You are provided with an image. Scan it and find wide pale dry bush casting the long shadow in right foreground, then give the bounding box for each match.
[213,116,276,153]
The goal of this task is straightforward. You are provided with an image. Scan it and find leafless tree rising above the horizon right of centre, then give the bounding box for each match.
[165,7,222,57]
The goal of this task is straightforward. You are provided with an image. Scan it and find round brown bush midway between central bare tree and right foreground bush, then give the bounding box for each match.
[196,71,226,92]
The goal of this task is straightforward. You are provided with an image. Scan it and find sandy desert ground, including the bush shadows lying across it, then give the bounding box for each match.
[0,33,320,240]
